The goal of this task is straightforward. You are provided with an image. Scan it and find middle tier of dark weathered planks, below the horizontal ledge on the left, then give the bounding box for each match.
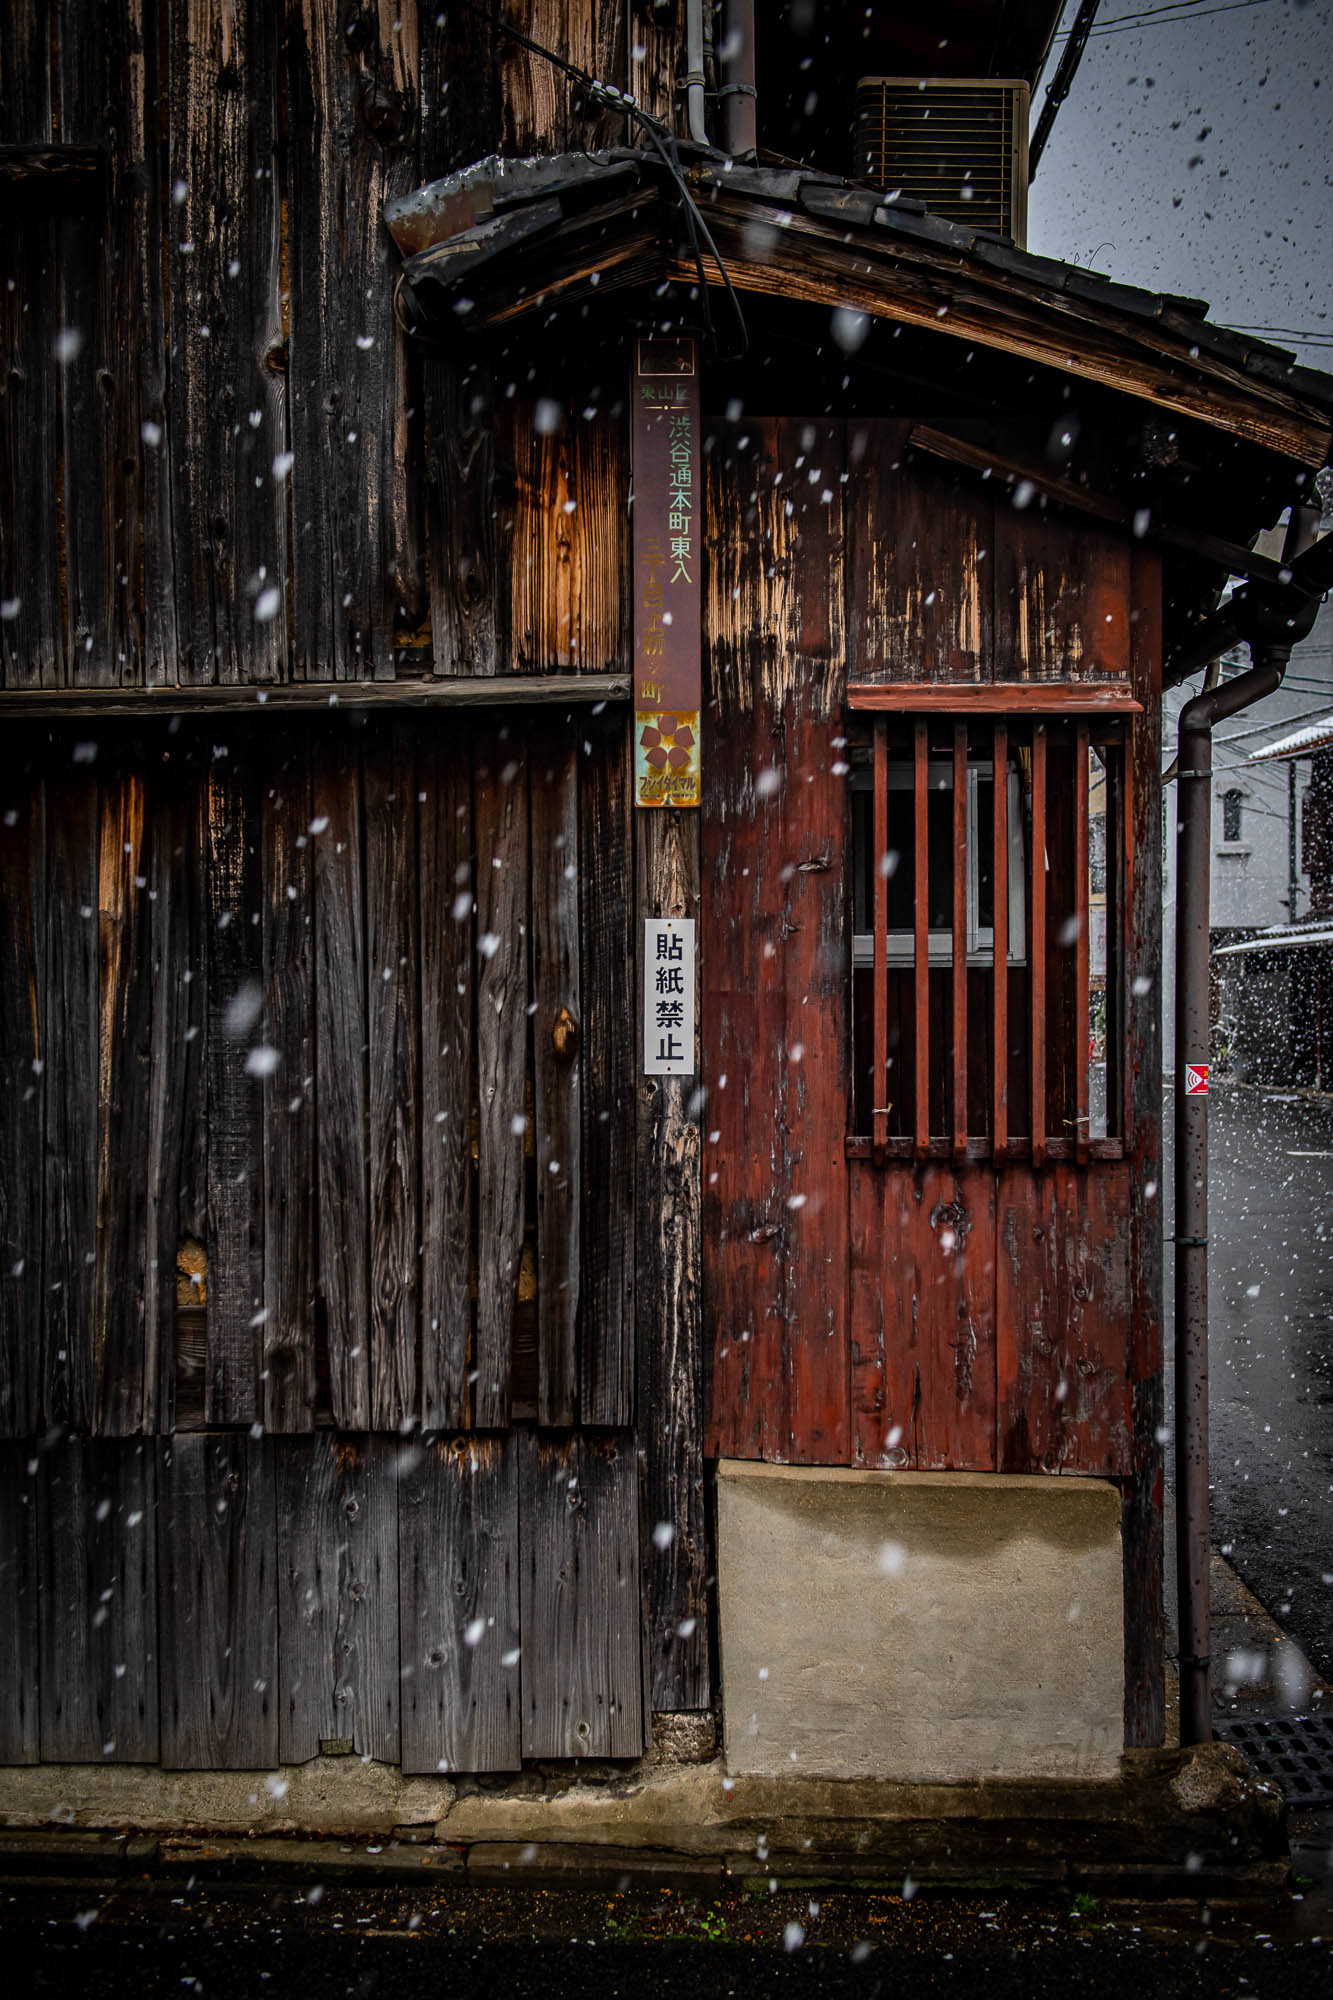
[0,714,634,1436]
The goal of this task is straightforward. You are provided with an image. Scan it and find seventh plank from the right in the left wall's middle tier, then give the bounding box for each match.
[260,742,314,1430]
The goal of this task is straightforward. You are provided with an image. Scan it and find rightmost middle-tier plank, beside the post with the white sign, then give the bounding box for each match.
[578,714,632,1426]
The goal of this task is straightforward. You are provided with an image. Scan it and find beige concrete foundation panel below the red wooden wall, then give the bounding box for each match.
[719,1460,1123,1784]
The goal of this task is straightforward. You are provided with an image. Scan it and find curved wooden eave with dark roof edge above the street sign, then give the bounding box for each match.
[386,150,1333,470]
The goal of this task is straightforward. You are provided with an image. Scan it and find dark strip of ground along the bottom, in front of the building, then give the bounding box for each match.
[0,1884,1333,2000]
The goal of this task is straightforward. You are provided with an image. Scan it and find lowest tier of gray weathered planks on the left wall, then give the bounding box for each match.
[0,1430,646,1772]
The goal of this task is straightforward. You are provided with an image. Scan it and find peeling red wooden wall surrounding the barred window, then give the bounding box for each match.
[703,418,1161,1742]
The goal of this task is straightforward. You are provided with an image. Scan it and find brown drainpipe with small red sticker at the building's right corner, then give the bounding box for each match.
[1175,506,1319,1744]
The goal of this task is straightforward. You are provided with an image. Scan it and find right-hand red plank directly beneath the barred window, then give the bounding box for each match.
[995,1162,1131,1474]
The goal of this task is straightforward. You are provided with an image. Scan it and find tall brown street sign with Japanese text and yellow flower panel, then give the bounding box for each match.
[632,336,703,806]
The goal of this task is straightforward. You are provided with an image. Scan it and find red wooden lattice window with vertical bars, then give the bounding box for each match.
[851,684,1137,1166]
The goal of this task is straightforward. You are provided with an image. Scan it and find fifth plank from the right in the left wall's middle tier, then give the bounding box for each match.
[364,722,420,1430]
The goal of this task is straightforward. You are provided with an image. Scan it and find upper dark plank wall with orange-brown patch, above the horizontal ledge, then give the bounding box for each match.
[0,0,679,688]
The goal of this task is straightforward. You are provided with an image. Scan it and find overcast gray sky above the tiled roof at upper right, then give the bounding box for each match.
[1029,0,1333,372]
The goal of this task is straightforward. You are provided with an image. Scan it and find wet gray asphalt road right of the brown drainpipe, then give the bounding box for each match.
[1167,1084,1333,1680]
